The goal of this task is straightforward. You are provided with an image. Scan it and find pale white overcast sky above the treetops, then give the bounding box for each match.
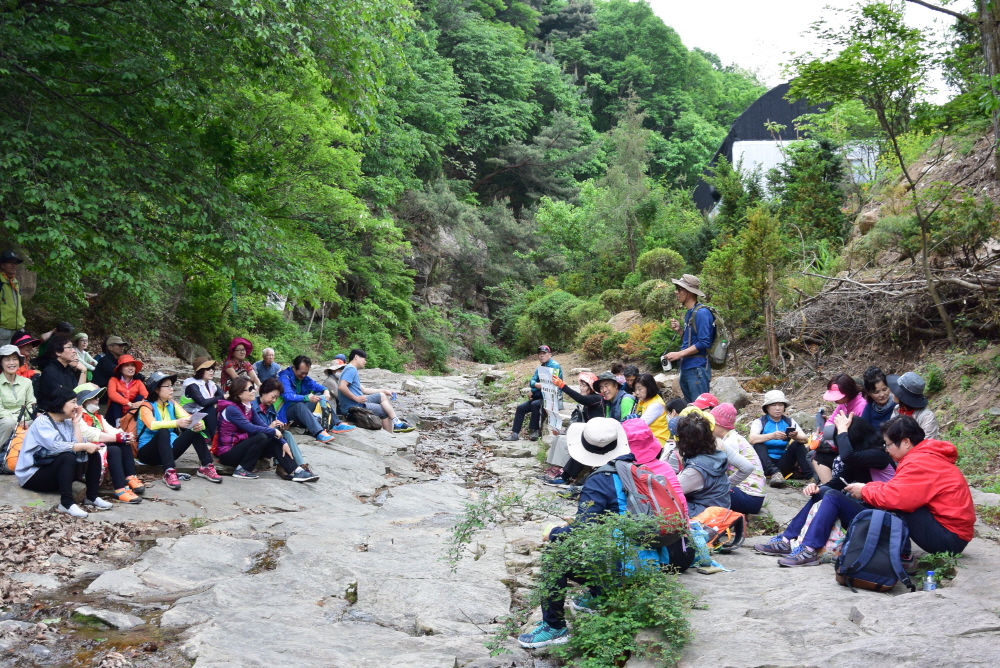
[649,0,972,102]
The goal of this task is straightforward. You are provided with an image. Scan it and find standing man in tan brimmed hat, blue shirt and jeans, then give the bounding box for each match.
[664,274,715,403]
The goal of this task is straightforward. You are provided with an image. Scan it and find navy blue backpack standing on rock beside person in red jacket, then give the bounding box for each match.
[834,509,916,592]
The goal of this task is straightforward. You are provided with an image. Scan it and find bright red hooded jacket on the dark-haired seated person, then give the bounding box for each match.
[861,439,976,541]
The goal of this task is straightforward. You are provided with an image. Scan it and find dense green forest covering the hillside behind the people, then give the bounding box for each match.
[7,0,997,370]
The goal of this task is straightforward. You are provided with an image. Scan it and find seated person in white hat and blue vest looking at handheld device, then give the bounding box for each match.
[747,390,815,487]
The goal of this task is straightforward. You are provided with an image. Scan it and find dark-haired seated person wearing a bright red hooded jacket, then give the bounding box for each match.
[844,416,976,554]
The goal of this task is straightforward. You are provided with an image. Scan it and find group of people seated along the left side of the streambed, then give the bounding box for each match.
[0,323,414,517]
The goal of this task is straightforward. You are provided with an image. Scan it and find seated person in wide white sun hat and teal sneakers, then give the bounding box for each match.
[517,417,693,649]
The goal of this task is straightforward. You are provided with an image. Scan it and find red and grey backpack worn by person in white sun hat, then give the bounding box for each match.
[594,460,688,549]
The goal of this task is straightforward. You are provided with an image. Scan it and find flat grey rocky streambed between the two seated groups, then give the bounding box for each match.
[0,365,1000,668]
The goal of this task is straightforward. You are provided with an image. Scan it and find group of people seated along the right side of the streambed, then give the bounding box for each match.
[512,346,975,648]
